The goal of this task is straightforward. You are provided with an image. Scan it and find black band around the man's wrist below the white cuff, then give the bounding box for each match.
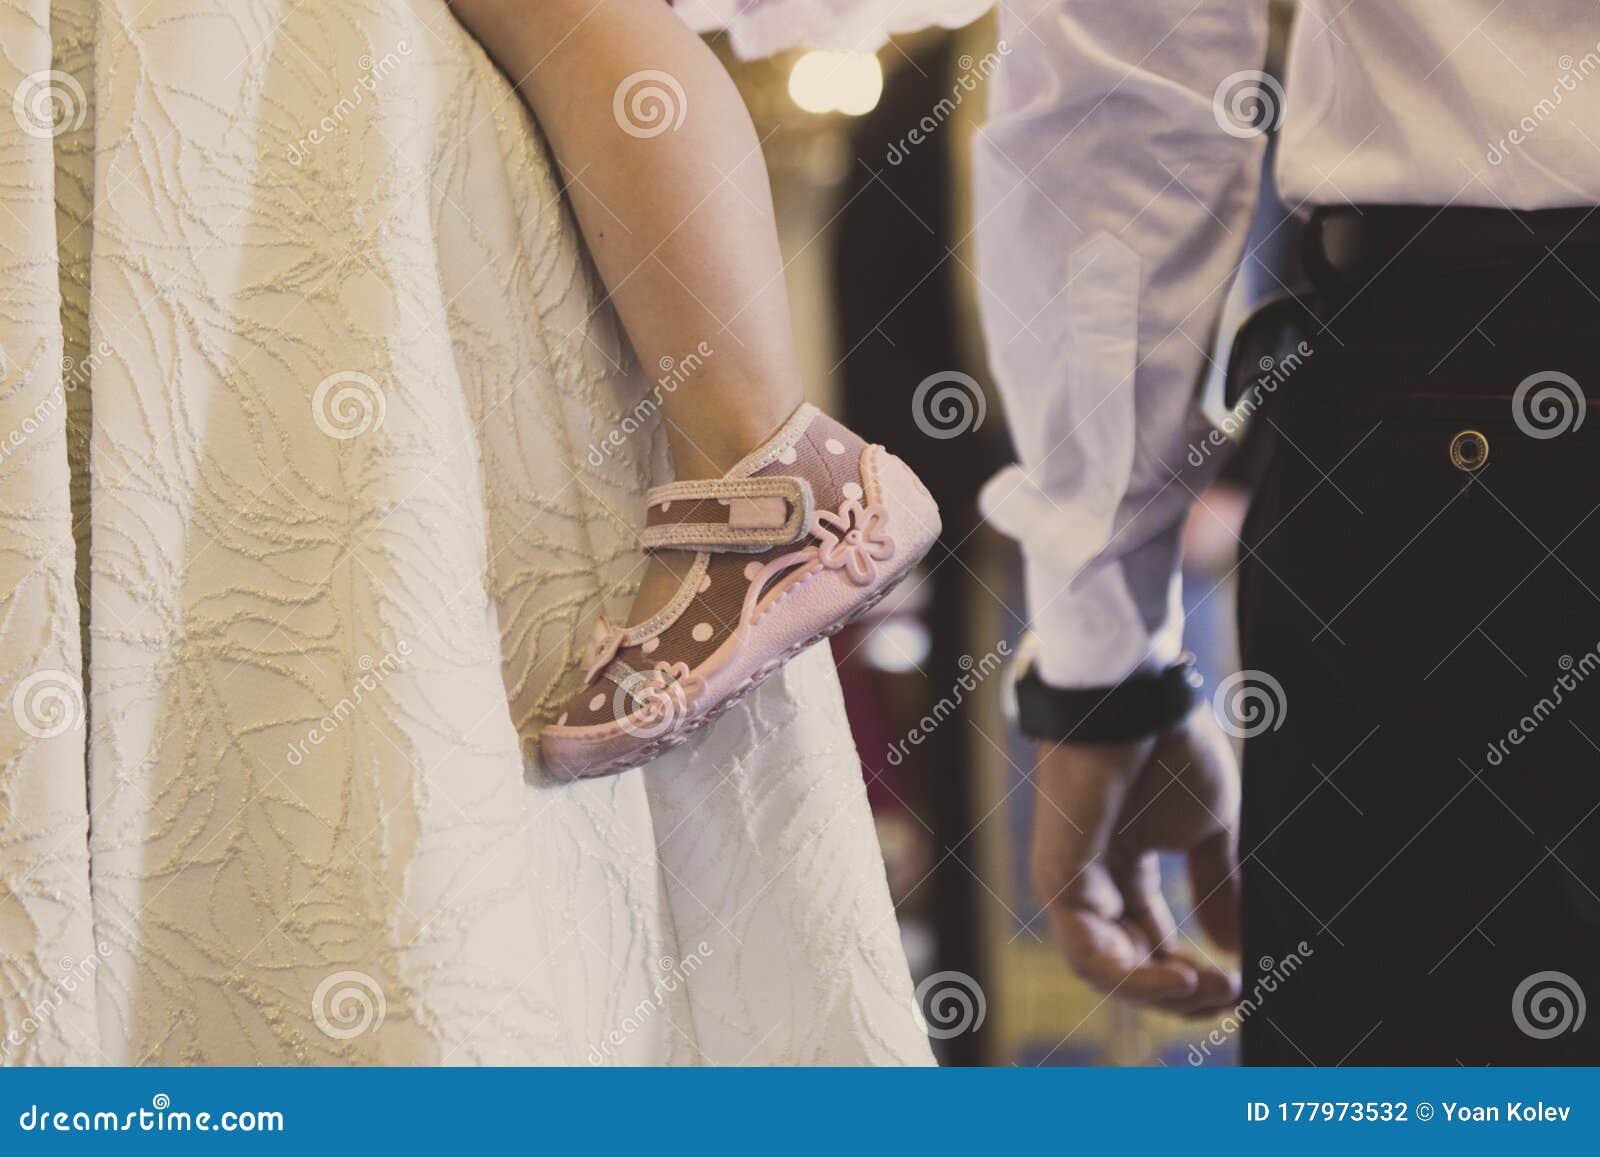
[1016,653,1202,743]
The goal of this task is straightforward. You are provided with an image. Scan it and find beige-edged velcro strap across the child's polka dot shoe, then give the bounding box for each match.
[643,475,814,554]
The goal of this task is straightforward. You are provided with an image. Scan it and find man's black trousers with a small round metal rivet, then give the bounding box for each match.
[1240,218,1600,1066]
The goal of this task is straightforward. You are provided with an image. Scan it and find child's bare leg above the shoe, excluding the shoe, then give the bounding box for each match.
[451,0,802,478]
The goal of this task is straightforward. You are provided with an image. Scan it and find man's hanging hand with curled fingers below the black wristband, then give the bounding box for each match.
[1030,707,1238,1016]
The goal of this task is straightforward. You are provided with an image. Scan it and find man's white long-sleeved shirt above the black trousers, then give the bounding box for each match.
[976,0,1600,687]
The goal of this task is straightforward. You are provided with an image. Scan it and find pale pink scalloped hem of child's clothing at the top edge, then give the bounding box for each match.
[674,0,995,59]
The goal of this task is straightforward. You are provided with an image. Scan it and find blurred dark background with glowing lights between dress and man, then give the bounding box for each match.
[714,3,1296,1066]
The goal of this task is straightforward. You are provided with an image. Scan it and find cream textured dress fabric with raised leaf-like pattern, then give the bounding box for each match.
[0,0,930,1064]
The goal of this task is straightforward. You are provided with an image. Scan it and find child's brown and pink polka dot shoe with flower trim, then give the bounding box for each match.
[539,405,939,779]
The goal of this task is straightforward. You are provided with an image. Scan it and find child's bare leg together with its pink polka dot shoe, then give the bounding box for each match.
[453,0,939,778]
